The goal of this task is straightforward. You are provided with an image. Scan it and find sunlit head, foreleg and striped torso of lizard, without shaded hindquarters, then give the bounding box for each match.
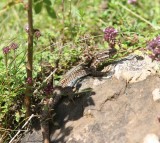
[60,48,117,87]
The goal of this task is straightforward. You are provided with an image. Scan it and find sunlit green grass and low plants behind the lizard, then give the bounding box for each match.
[0,0,160,142]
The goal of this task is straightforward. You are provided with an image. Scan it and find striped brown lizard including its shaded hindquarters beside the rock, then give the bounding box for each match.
[51,48,117,109]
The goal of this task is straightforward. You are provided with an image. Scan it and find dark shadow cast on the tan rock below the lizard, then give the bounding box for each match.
[50,86,95,143]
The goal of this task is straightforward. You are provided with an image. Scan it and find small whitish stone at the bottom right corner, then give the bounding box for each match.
[143,134,160,143]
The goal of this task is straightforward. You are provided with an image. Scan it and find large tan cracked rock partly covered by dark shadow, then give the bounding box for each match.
[22,54,160,143]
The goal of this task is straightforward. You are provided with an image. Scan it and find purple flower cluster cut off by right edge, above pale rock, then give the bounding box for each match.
[147,36,160,61]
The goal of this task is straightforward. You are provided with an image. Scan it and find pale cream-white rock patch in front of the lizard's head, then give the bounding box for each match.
[114,55,160,83]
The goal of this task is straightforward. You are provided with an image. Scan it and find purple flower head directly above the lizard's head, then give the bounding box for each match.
[104,27,118,48]
